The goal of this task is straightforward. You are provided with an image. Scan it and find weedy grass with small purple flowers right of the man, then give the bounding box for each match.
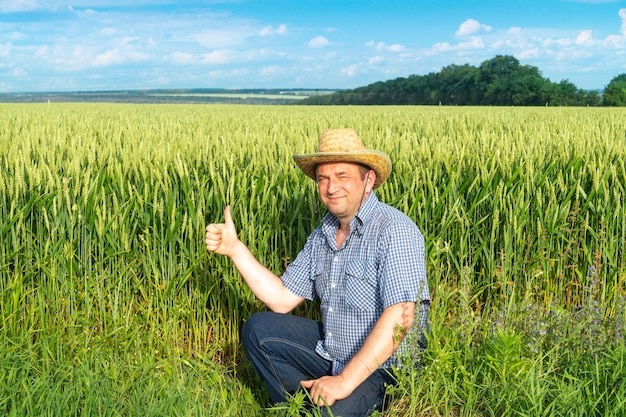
[389,268,626,416]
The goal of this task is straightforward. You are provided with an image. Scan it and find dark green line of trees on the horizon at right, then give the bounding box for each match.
[298,55,626,106]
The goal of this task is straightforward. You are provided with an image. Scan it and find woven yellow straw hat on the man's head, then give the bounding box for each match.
[293,129,391,188]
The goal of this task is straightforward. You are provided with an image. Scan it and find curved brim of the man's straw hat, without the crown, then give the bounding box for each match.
[293,149,391,188]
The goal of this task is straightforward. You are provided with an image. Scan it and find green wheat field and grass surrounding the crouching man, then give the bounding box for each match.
[0,104,626,415]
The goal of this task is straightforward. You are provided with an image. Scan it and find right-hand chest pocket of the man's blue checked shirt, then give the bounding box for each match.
[346,262,381,311]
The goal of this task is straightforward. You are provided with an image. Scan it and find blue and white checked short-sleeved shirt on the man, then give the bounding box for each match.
[282,193,430,375]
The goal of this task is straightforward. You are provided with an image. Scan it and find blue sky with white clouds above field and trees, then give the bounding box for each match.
[0,0,626,92]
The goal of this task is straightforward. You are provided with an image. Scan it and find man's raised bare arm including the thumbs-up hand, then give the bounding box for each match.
[205,206,303,313]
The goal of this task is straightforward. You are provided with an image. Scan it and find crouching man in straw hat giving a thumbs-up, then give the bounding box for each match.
[206,129,430,417]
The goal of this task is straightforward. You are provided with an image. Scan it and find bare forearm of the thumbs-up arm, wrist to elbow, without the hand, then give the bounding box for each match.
[229,237,302,313]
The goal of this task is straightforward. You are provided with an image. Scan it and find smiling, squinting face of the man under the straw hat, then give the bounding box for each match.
[316,162,376,224]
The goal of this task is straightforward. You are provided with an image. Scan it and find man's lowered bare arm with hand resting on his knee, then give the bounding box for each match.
[301,302,415,406]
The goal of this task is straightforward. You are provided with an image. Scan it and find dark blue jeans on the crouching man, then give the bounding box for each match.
[242,312,395,417]
